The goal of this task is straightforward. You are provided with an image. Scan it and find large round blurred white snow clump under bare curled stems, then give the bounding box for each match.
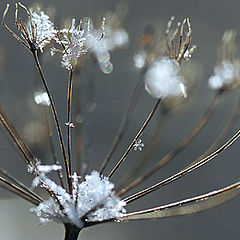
[145,58,186,98]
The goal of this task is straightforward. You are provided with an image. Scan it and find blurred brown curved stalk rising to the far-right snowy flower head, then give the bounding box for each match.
[118,94,222,196]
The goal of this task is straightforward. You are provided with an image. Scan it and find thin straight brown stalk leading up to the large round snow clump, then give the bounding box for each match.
[108,98,161,178]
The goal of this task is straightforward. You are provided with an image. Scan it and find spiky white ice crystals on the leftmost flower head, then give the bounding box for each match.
[27,11,56,52]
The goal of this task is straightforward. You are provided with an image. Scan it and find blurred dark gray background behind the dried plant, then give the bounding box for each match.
[0,0,240,240]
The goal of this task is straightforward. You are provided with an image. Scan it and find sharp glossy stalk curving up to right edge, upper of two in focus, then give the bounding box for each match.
[124,125,240,203]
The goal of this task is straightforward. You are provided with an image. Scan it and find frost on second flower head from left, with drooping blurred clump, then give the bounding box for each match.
[51,18,113,74]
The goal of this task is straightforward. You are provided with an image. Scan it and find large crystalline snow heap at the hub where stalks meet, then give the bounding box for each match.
[30,168,126,228]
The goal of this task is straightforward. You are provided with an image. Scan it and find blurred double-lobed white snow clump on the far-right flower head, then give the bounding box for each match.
[208,61,235,89]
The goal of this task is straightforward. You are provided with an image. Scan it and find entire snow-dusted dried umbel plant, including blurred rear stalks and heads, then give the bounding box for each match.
[0,3,240,240]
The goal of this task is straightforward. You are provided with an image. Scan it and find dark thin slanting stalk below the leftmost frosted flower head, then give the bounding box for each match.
[33,51,72,191]
